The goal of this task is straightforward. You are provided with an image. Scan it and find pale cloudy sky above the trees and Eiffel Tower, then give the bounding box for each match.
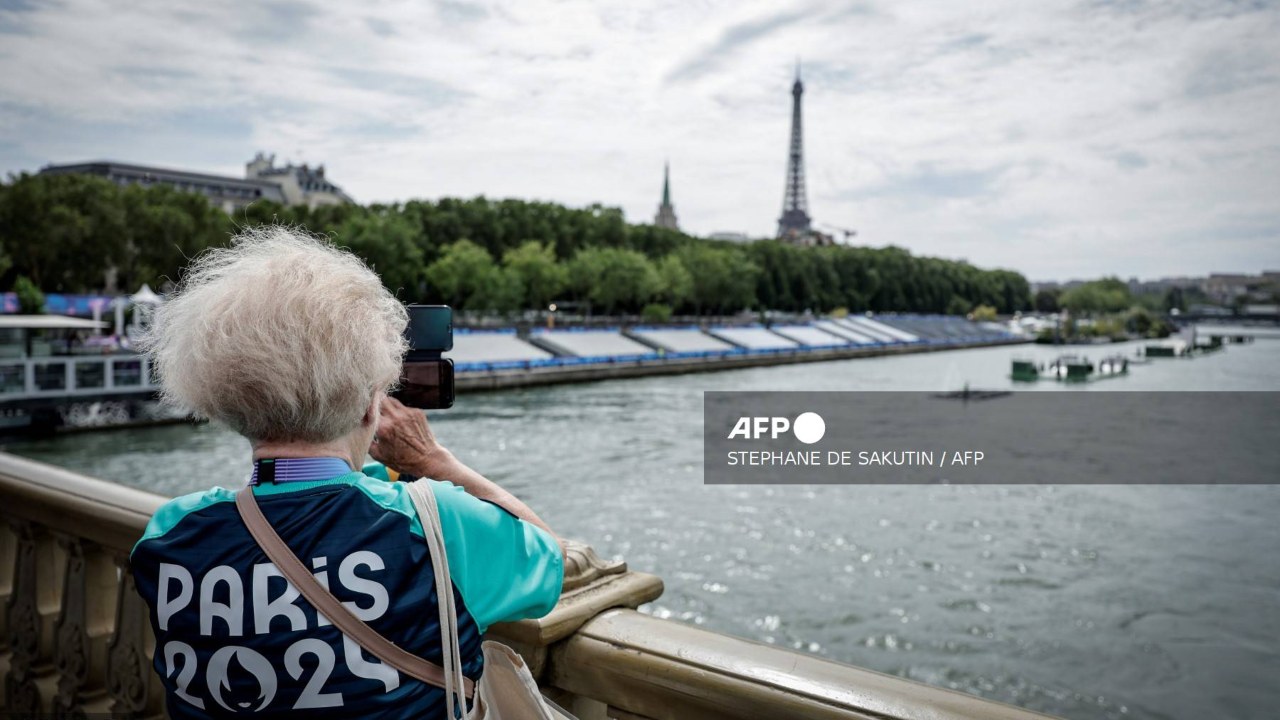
[0,0,1280,279]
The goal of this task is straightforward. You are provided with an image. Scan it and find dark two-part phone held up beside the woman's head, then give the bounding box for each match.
[392,305,453,410]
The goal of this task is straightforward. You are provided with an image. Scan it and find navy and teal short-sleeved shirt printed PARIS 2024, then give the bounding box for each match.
[131,465,564,720]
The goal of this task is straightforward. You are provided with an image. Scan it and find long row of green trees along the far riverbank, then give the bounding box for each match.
[0,174,1032,314]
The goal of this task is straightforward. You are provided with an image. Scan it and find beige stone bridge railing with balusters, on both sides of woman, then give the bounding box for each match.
[0,454,1044,720]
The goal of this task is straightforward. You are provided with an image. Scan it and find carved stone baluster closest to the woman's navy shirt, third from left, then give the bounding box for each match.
[106,555,164,717]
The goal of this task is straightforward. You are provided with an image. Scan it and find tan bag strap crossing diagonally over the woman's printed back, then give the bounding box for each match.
[236,487,475,697]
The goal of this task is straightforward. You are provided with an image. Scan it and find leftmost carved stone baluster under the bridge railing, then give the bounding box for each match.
[5,520,61,715]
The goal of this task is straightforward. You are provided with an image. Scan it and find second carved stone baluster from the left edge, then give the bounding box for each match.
[54,536,118,717]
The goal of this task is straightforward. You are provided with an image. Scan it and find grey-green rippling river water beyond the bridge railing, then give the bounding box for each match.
[6,340,1280,719]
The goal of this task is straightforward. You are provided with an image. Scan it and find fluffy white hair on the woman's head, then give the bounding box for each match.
[143,225,408,442]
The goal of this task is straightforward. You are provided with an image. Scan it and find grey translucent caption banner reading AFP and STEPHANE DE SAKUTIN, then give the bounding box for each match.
[703,391,1280,484]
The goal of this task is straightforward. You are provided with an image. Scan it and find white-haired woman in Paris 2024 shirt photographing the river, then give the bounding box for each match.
[132,227,563,719]
